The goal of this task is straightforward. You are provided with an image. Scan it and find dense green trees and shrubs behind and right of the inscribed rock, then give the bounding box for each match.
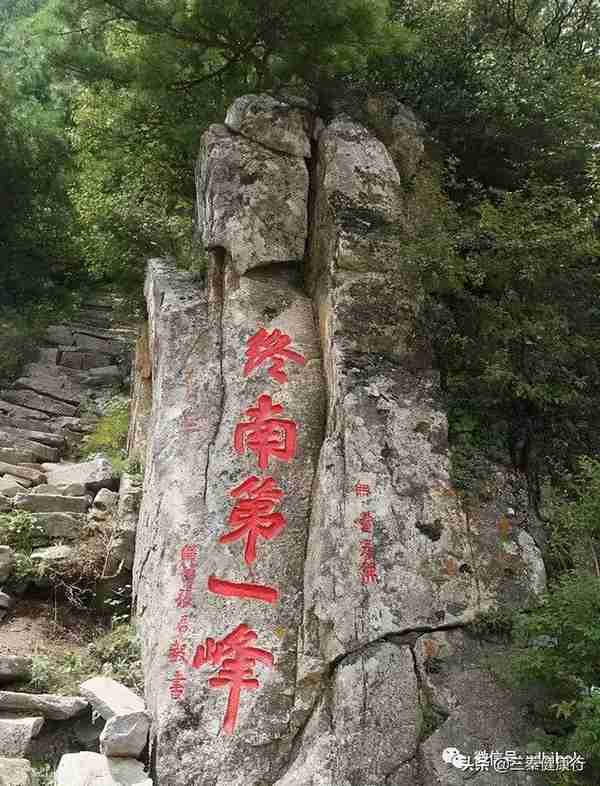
[0,0,600,777]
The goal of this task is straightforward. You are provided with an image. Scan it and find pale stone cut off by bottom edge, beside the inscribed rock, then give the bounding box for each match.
[54,753,152,786]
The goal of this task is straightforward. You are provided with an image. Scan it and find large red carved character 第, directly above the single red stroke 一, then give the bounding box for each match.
[219,475,287,565]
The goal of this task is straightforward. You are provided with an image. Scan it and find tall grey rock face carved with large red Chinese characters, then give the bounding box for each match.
[133,96,545,786]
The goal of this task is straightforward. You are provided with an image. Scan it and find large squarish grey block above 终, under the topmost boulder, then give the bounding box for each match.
[197,120,308,275]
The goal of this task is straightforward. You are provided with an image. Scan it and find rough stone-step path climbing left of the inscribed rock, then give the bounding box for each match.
[0,299,152,786]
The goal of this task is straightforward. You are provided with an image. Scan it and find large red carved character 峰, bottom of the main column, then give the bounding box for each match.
[192,625,273,734]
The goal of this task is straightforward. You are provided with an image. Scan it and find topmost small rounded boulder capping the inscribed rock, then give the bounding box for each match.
[225,95,314,158]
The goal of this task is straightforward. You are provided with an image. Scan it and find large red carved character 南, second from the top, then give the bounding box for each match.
[234,394,297,469]
